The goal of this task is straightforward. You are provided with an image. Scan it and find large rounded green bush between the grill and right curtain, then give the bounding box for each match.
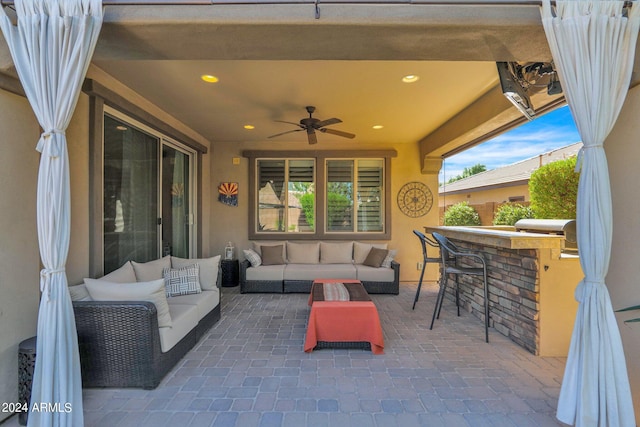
[529,156,580,219]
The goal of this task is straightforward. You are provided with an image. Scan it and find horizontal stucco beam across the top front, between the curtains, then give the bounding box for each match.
[94,5,550,61]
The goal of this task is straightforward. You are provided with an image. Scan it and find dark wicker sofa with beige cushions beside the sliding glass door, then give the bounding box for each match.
[69,256,220,389]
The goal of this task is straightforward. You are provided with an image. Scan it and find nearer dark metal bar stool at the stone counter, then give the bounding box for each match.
[429,233,489,342]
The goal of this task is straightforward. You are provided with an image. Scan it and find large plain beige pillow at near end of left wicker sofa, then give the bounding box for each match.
[84,279,172,328]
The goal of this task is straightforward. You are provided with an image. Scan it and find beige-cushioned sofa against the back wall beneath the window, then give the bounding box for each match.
[240,241,400,295]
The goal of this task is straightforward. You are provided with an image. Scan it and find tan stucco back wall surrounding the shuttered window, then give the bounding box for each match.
[210,141,438,283]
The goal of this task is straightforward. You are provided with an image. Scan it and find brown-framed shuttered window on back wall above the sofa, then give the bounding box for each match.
[243,150,395,239]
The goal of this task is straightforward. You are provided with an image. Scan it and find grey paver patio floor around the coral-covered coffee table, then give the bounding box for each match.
[5,284,565,427]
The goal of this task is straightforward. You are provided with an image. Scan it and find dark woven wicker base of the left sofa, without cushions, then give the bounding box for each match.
[73,301,220,389]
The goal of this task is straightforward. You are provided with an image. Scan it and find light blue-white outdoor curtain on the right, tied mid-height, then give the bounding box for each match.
[541,0,640,427]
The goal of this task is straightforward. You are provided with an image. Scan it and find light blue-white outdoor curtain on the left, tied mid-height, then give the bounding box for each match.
[0,0,102,427]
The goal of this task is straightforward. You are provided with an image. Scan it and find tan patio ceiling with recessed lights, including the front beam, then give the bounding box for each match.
[0,2,568,156]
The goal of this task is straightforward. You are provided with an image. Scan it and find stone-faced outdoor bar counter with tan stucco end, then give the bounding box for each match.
[425,227,583,356]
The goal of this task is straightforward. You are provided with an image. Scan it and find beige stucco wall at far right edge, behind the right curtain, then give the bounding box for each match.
[605,86,640,423]
